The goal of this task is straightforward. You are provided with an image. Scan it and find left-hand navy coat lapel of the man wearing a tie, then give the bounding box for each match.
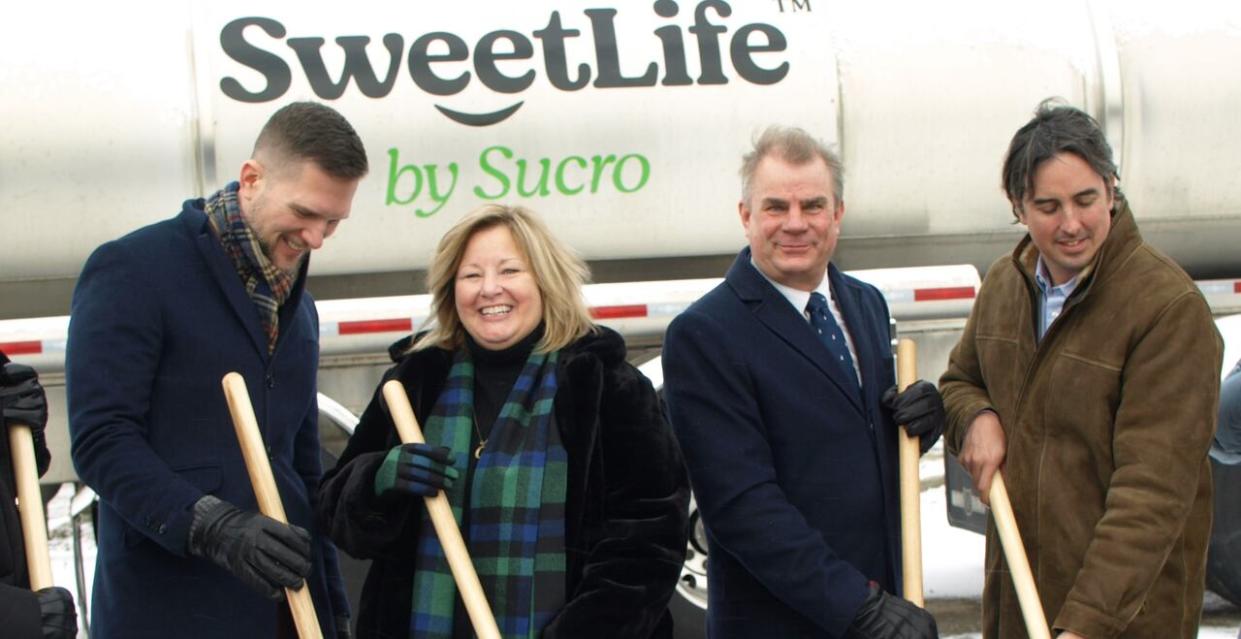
[725,248,865,414]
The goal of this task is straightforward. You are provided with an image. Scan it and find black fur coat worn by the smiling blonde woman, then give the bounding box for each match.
[318,328,690,639]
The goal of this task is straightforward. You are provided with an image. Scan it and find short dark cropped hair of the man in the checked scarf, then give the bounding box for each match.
[253,102,370,180]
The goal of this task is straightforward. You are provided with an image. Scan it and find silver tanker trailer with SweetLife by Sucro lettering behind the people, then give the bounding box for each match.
[0,0,1241,632]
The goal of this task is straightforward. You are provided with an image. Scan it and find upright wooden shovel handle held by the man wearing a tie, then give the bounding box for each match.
[896,337,926,608]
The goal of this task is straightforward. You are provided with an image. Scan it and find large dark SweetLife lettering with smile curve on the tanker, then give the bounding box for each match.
[220,0,789,127]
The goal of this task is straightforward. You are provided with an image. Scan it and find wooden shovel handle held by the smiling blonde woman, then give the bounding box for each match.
[383,380,500,639]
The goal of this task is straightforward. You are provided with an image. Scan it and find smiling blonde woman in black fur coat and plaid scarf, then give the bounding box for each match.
[319,205,689,638]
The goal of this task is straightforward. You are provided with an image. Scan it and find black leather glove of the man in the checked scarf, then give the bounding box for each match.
[189,495,310,601]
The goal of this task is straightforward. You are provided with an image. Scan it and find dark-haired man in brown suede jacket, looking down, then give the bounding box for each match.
[939,102,1222,639]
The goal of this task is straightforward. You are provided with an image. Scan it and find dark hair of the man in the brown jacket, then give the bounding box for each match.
[1001,98,1119,215]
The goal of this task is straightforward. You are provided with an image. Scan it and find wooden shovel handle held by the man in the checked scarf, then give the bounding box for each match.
[223,372,323,639]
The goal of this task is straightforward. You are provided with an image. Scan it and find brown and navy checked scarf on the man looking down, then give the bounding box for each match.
[206,181,294,355]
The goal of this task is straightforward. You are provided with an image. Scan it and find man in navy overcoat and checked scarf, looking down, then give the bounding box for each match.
[66,102,367,639]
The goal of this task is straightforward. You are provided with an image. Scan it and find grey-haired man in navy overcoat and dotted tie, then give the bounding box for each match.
[663,128,943,639]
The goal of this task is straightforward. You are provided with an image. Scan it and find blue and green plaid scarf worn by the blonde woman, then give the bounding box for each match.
[410,349,568,639]
